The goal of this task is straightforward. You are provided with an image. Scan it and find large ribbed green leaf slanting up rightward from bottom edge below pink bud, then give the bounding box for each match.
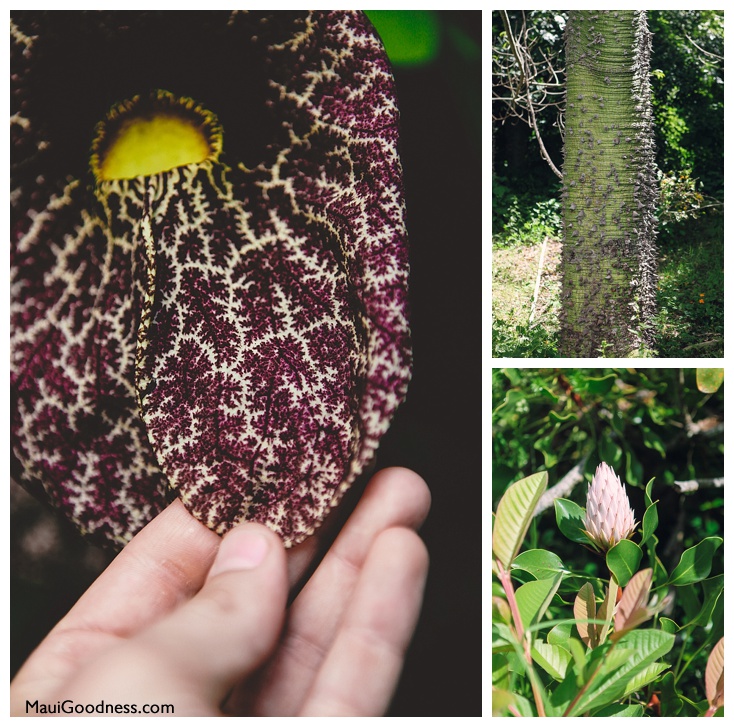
[569,629,675,717]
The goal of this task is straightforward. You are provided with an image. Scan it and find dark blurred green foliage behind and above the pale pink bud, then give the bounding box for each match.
[492,368,724,560]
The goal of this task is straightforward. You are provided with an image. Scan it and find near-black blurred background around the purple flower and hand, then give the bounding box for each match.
[11,11,482,716]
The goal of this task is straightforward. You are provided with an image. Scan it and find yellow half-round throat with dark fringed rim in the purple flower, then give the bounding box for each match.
[91,91,222,181]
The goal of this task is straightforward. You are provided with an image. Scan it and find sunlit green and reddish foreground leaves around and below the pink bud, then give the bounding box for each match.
[492,472,724,716]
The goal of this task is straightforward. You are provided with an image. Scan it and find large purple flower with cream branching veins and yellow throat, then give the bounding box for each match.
[11,11,410,545]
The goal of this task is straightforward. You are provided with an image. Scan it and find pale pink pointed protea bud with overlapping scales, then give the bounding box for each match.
[584,462,637,550]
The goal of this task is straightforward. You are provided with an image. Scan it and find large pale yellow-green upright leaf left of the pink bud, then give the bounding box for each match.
[492,472,548,570]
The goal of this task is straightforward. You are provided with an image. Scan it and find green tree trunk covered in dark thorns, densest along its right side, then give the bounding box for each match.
[560,10,657,356]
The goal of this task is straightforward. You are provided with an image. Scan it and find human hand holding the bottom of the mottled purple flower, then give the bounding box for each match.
[11,468,430,716]
